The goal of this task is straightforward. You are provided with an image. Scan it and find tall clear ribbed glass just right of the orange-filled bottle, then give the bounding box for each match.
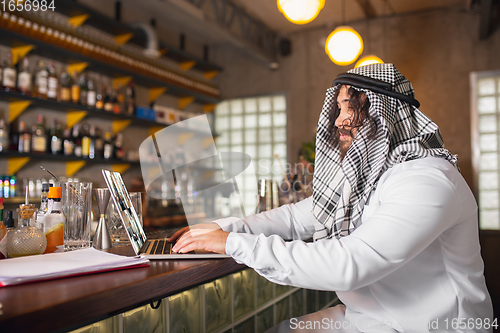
[61,182,92,251]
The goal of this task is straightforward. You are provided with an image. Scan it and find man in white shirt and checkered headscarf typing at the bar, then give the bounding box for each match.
[172,64,493,332]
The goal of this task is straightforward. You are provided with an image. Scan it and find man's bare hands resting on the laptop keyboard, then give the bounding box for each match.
[169,223,229,254]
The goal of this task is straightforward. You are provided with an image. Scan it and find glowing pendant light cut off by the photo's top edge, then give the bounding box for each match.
[278,0,325,24]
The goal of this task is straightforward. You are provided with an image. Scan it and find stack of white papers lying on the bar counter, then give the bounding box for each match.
[0,247,149,287]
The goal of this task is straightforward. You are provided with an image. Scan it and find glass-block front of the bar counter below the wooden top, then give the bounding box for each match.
[71,269,339,333]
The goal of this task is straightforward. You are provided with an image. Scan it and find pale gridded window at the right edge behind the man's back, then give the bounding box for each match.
[471,72,500,230]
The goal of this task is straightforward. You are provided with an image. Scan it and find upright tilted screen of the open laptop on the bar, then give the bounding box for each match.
[102,169,146,254]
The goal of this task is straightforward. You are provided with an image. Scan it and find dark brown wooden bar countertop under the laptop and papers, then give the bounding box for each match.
[0,247,246,333]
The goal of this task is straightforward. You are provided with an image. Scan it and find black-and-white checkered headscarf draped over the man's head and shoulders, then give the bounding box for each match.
[313,64,457,240]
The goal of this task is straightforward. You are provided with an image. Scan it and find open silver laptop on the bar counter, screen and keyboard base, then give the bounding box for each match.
[102,169,230,259]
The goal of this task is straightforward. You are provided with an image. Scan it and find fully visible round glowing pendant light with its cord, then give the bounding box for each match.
[325,1,363,66]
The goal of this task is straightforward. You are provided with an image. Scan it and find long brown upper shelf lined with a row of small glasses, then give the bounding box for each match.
[0,6,220,105]
